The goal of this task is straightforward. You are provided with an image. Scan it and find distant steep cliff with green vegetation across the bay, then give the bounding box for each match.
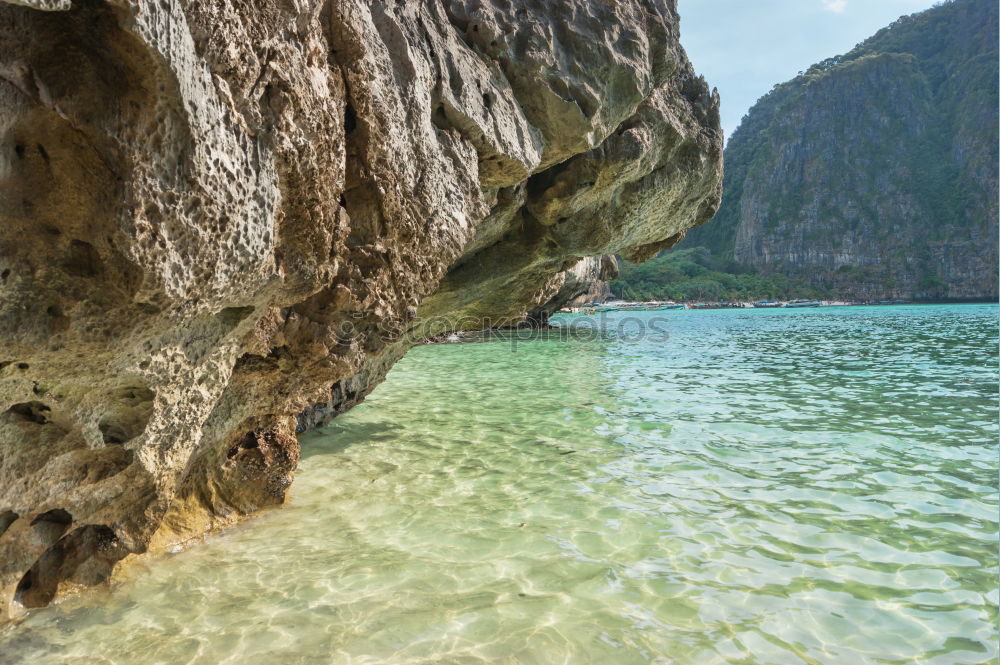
[684,0,998,300]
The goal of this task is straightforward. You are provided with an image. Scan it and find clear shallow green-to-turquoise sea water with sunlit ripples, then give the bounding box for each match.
[0,305,998,665]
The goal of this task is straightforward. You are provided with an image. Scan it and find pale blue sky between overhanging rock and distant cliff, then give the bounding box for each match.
[678,0,937,138]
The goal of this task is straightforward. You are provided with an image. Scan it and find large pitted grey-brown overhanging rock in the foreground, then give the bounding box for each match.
[0,0,721,618]
